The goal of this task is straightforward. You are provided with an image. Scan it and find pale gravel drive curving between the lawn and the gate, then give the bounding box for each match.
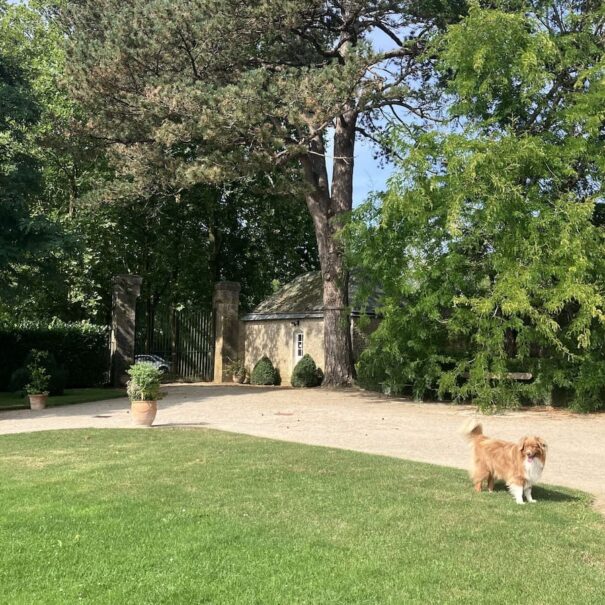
[0,385,605,511]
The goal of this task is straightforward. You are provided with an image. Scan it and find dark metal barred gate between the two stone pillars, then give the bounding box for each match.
[135,304,214,381]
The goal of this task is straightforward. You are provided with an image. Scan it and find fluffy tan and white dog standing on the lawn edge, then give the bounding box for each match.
[462,420,547,504]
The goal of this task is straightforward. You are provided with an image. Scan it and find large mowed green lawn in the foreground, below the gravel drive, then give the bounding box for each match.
[0,429,605,605]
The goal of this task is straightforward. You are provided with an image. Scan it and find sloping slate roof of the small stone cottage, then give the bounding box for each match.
[242,271,374,321]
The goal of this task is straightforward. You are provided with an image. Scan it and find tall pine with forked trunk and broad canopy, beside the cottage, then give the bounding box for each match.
[63,0,464,385]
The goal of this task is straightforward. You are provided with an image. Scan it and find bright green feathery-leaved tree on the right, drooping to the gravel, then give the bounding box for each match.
[348,2,605,410]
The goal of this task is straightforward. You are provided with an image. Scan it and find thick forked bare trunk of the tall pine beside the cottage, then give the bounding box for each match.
[303,111,357,386]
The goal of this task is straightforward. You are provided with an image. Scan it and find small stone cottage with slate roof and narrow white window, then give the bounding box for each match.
[242,271,378,384]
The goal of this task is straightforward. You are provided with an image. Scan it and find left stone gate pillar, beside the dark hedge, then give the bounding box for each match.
[110,275,143,387]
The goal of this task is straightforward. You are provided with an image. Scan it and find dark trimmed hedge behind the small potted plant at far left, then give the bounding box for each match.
[0,320,109,391]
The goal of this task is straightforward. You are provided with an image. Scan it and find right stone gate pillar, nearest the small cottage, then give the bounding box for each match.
[212,281,240,382]
